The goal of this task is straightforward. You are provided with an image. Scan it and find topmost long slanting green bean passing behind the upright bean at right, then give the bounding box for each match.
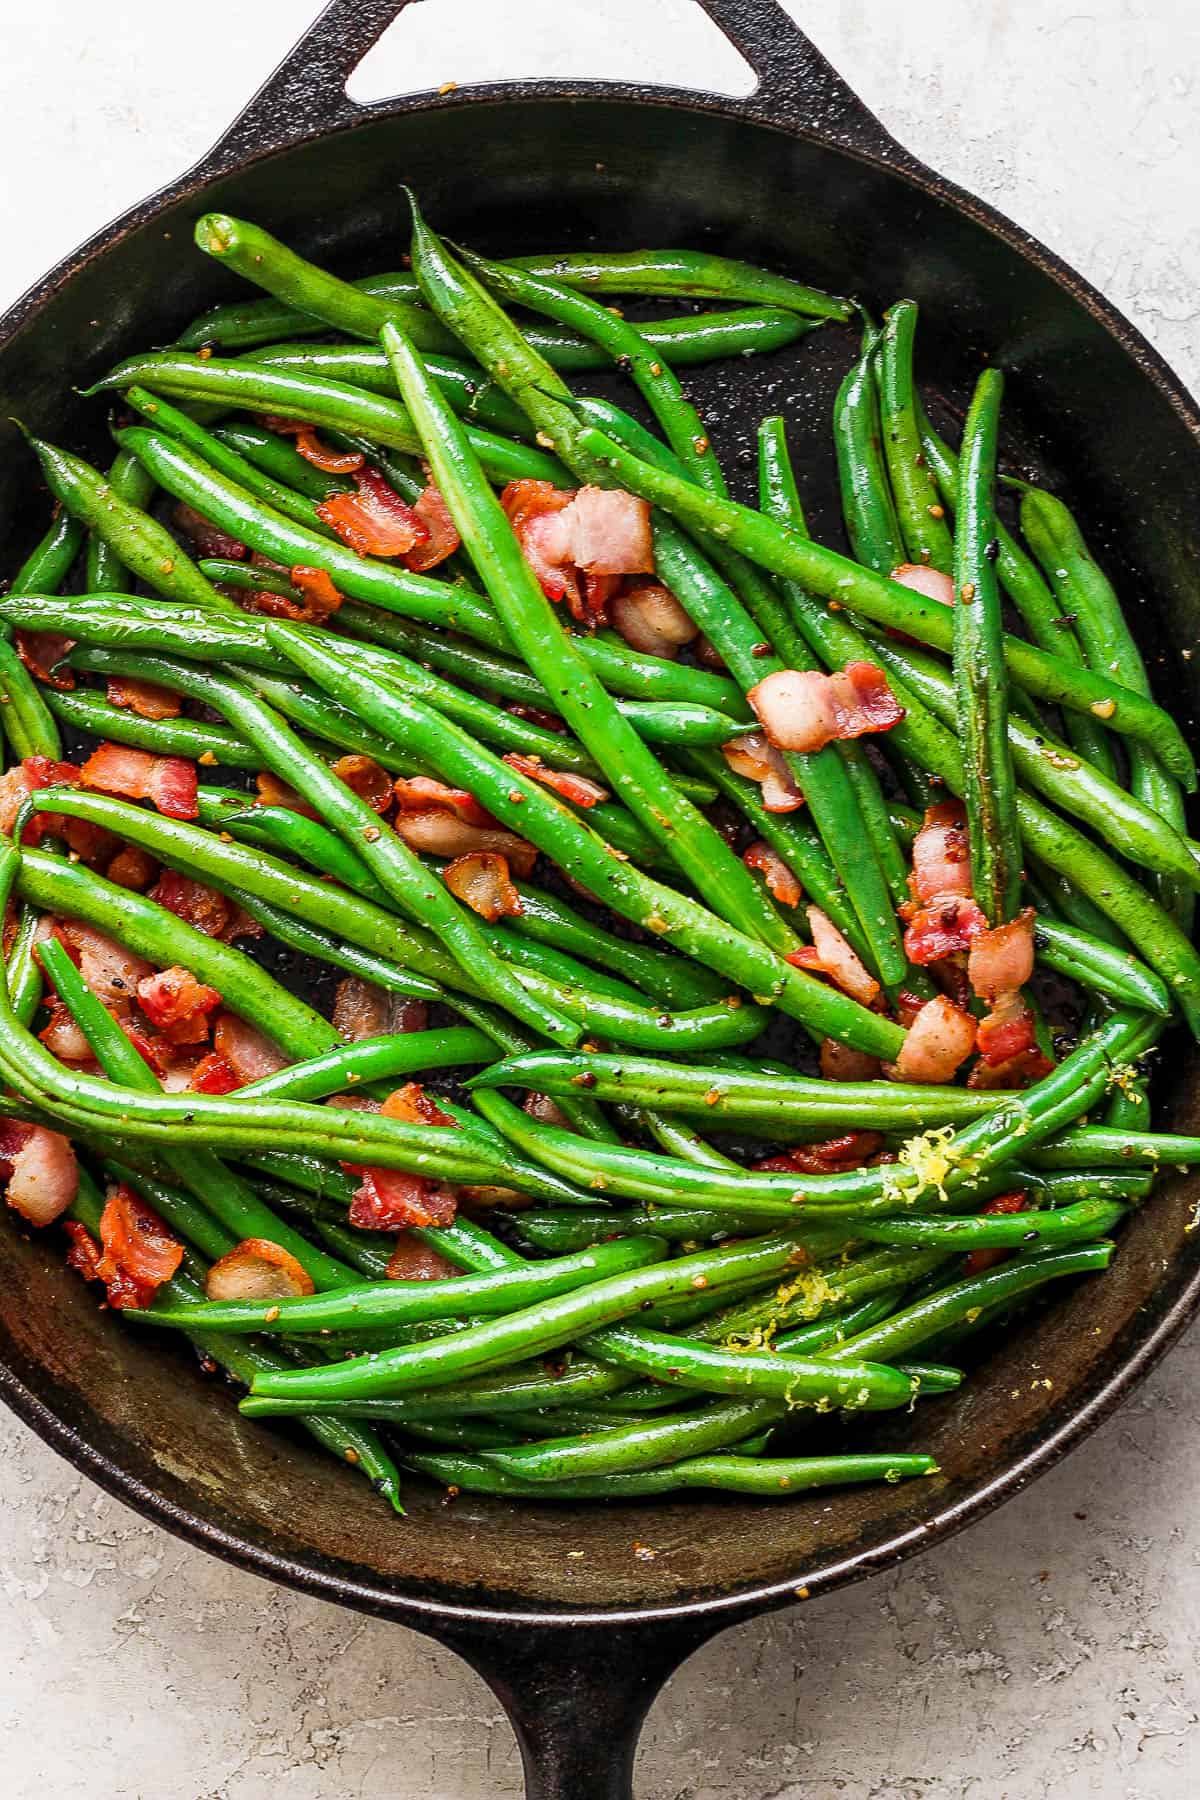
[579,425,1195,792]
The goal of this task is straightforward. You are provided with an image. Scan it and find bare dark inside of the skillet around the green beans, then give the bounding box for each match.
[0,97,1200,1613]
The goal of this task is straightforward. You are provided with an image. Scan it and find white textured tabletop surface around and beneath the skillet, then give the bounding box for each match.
[0,0,1200,1800]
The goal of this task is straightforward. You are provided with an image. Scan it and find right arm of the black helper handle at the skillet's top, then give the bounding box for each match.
[700,0,907,162]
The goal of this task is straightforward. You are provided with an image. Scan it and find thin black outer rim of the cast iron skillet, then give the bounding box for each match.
[0,81,1200,1636]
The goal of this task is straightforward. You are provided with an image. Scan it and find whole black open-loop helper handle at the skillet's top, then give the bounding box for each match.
[189,0,907,178]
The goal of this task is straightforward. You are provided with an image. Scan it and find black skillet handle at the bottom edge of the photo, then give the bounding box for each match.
[438,1615,730,1800]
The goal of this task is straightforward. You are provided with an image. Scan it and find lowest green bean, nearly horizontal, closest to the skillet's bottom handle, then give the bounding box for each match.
[401,1451,939,1501]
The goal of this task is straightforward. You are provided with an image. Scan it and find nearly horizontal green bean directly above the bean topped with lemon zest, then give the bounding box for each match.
[468,1049,1004,1136]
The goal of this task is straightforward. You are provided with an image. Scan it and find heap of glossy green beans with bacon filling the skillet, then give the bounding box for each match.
[0,203,1200,1510]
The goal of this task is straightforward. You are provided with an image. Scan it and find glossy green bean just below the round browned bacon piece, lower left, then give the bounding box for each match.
[142,1237,665,1339]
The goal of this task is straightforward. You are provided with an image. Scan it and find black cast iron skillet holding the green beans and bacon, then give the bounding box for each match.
[0,0,1200,1800]
